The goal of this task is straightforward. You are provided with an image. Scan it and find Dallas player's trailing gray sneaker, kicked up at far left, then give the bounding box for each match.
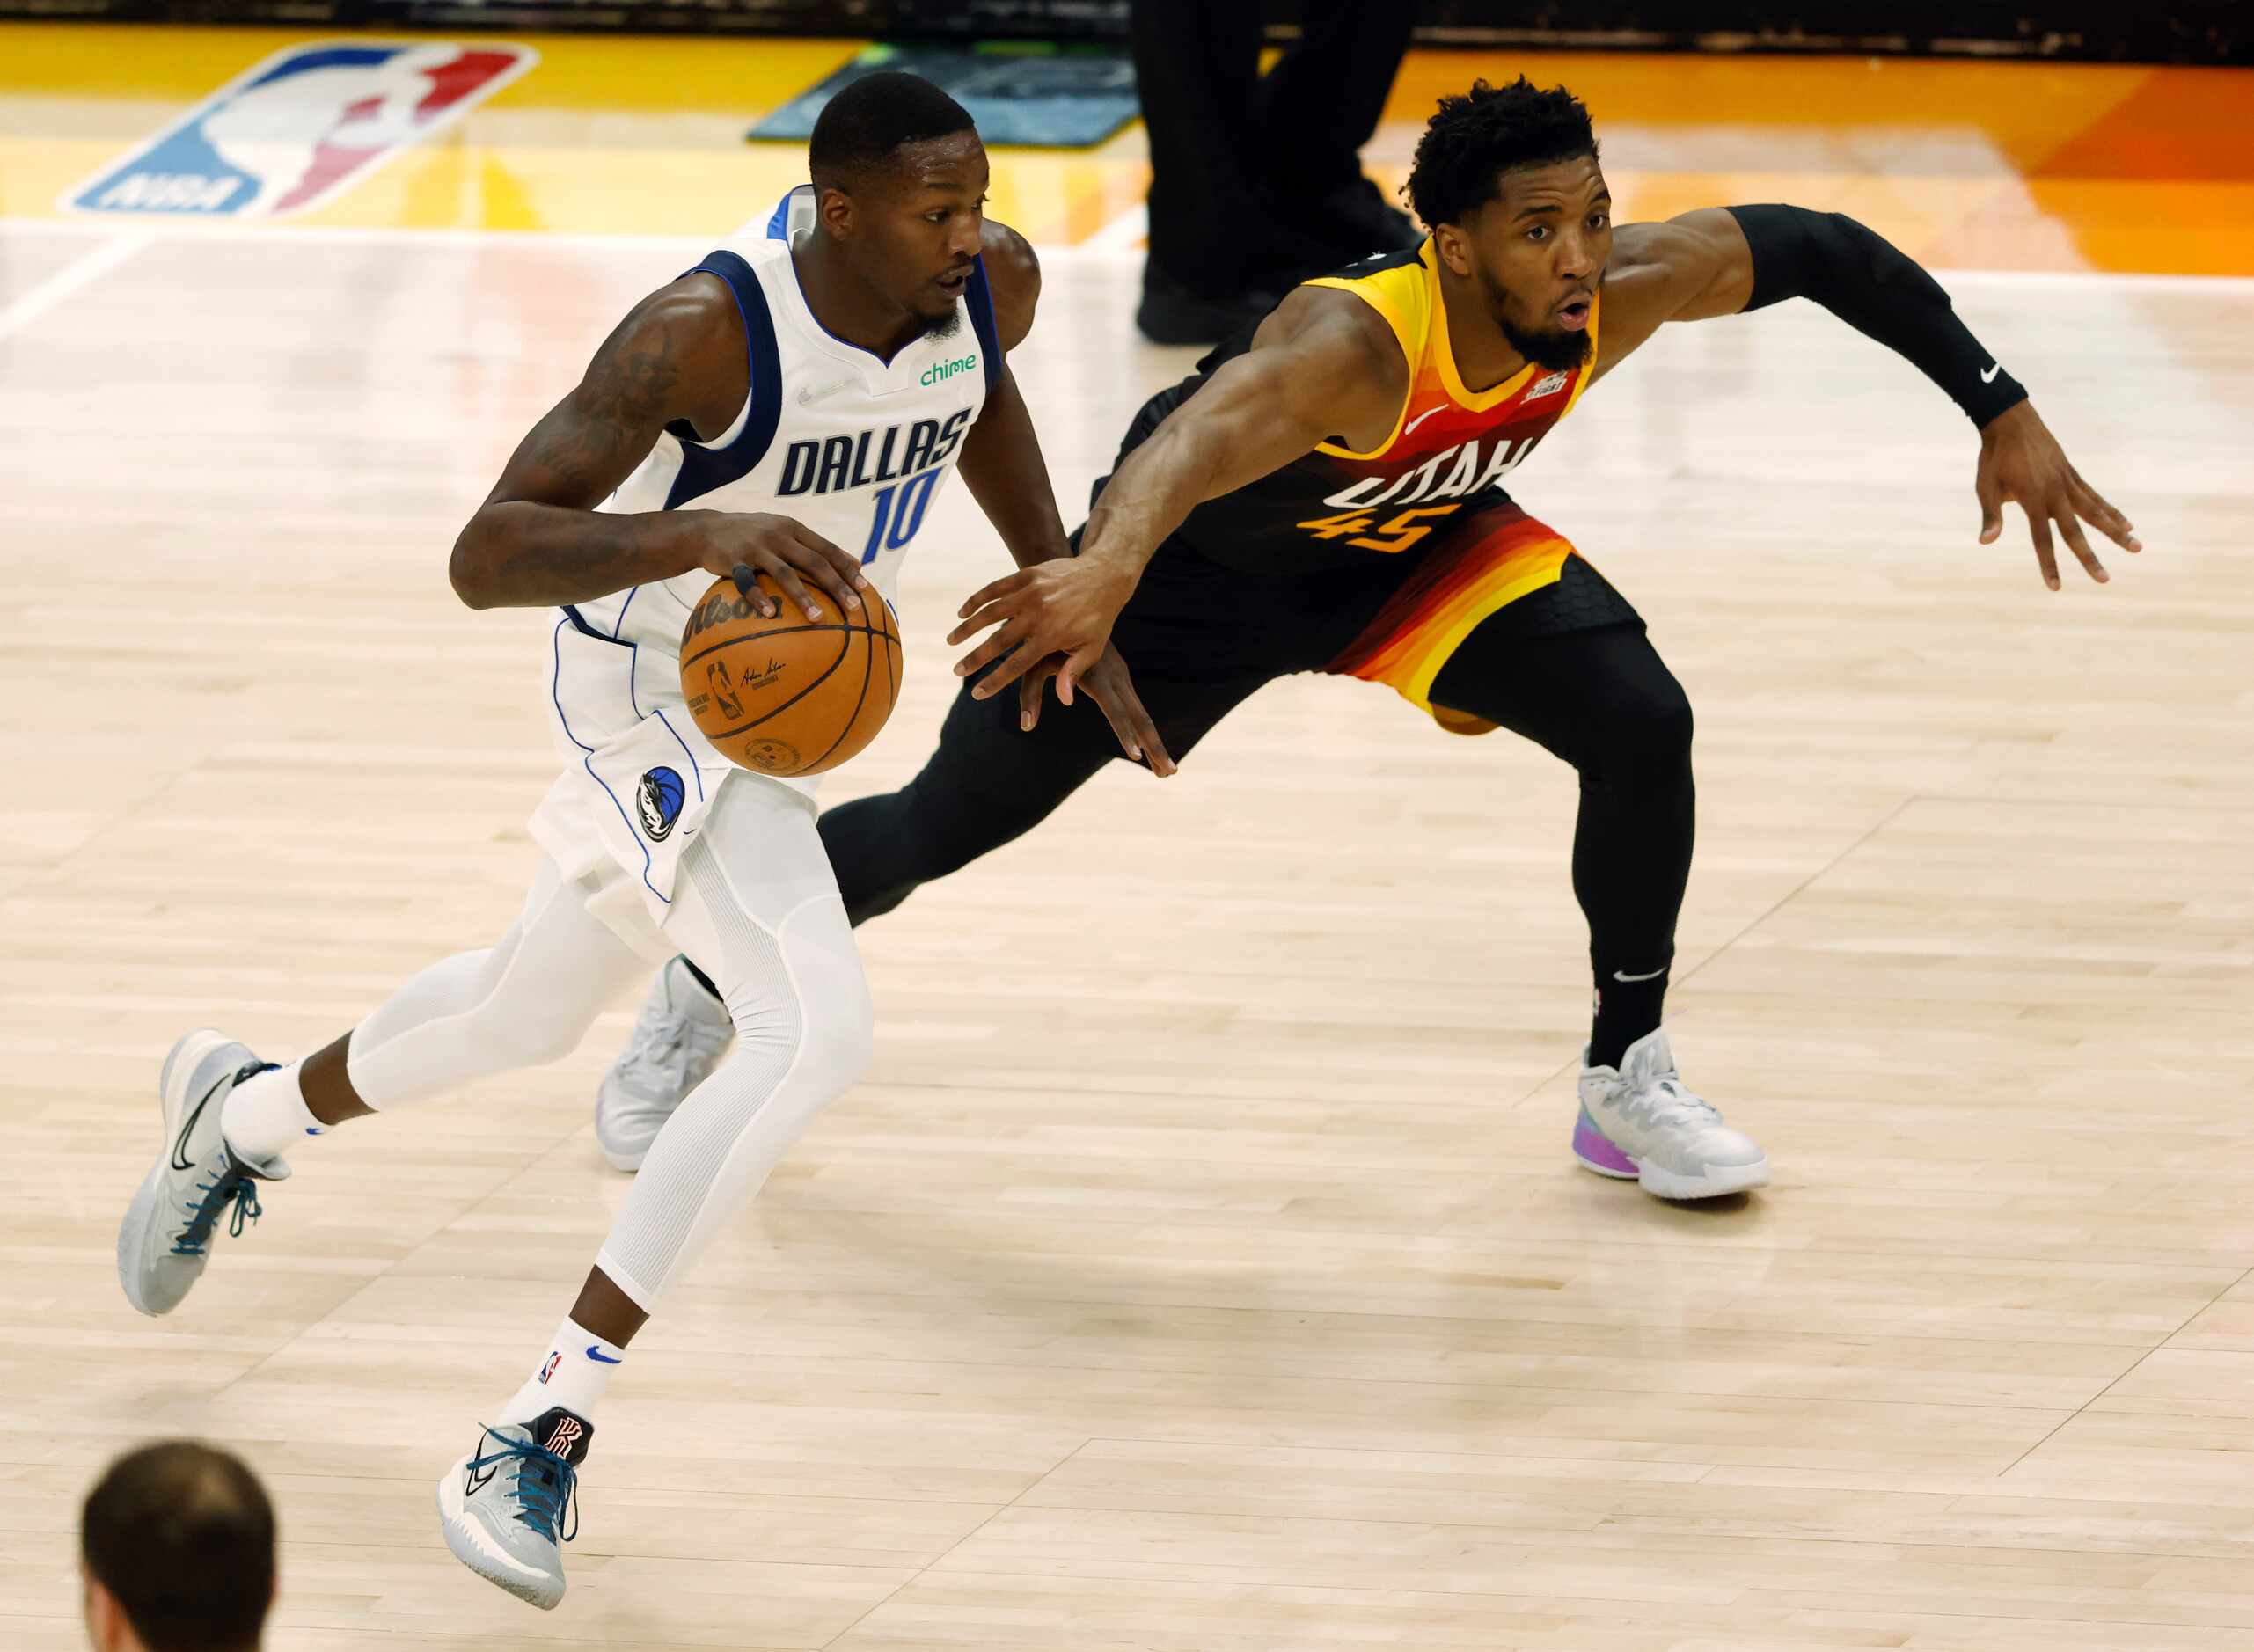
[117,1030,289,1314]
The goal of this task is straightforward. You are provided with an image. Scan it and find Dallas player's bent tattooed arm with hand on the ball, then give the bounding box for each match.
[449,275,866,615]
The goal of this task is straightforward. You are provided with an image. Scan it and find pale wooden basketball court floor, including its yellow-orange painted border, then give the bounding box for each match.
[0,29,2254,1652]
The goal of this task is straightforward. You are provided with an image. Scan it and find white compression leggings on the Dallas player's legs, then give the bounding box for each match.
[348,785,872,1312]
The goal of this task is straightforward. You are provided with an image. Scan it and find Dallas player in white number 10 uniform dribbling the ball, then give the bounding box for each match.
[117,75,1150,1607]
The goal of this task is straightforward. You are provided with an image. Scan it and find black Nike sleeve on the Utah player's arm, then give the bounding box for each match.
[1729,208,2026,426]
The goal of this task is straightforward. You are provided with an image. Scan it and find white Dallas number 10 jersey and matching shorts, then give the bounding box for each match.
[532,187,1003,909]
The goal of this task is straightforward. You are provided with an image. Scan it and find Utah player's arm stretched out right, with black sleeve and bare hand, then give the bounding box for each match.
[1598,205,2143,590]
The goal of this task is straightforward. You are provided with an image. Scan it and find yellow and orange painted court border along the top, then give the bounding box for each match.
[0,23,2254,275]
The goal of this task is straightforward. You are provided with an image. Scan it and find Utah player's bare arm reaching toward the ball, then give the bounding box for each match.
[947,289,1409,705]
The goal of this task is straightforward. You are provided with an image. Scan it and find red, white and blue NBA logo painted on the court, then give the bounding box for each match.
[63,40,538,219]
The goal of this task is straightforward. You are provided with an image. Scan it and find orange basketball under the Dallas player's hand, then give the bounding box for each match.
[681,574,902,778]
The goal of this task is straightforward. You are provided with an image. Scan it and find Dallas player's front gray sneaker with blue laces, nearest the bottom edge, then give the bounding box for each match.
[437,1407,595,1612]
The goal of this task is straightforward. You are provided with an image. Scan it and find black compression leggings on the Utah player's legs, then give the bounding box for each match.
[821,610,1695,1000]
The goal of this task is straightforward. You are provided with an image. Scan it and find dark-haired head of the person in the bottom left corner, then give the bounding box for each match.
[79,1440,275,1652]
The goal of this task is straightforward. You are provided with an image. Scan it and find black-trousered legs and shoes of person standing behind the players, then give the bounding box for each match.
[1130,0,1417,345]
